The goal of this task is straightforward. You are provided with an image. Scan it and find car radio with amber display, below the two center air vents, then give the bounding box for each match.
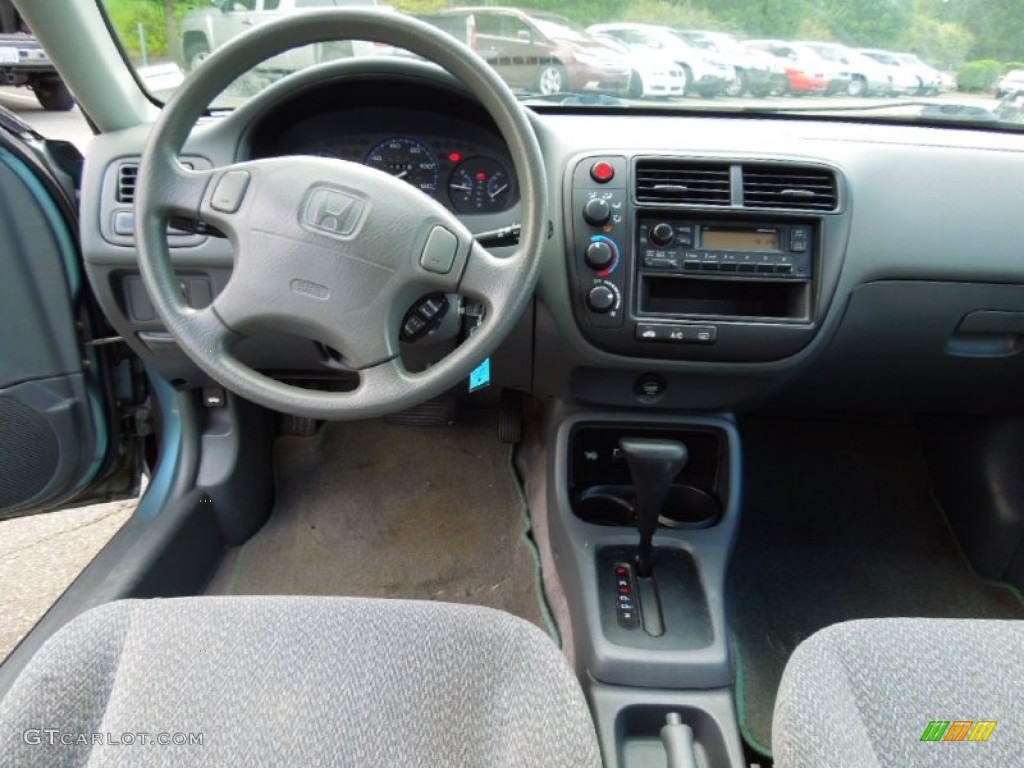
[637,214,812,281]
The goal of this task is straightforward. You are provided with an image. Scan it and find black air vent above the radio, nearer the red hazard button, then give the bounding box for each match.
[636,159,732,206]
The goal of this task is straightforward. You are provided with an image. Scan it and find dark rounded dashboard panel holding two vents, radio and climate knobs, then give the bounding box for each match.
[566,155,844,361]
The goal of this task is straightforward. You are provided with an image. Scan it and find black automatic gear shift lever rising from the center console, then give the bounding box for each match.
[618,437,689,579]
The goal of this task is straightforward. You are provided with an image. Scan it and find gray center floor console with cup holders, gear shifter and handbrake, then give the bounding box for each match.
[546,406,745,768]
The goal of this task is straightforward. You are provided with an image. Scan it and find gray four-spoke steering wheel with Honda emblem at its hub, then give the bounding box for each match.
[142,9,547,420]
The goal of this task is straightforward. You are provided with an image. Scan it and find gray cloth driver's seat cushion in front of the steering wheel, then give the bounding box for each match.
[0,597,601,768]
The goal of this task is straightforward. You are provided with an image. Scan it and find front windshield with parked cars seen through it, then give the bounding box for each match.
[99,0,1024,130]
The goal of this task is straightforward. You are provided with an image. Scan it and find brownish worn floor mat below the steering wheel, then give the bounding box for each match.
[207,412,547,629]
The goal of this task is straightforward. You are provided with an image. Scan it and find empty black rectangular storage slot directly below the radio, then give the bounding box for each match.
[639,274,810,321]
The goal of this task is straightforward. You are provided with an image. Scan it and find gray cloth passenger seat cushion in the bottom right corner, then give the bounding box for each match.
[772,618,1024,768]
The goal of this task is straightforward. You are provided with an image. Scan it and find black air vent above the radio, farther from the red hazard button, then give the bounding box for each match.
[743,165,839,211]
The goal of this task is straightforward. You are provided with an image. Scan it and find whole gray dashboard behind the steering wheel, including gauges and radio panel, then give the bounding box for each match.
[82,61,1024,421]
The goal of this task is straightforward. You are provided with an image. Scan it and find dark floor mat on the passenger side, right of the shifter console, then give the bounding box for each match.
[726,418,1024,752]
